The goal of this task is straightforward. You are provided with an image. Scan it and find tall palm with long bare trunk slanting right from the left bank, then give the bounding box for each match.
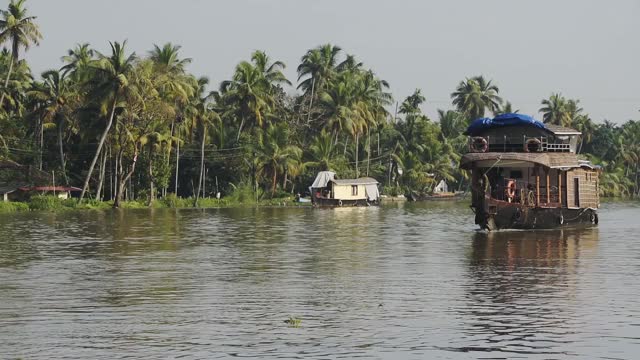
[80,40,136,201]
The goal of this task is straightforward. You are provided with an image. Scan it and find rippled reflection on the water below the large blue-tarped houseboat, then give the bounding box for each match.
[452,228,599,356]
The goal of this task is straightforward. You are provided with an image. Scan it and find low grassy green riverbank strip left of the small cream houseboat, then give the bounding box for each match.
[0,195,311,214]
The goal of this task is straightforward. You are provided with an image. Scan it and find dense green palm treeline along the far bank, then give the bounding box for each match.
[0,0,640,207]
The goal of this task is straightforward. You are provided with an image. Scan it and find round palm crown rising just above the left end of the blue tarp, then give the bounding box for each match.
[451,75,502,120]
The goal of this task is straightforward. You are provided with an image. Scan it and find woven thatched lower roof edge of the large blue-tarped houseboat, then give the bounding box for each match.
[460,152,582,170]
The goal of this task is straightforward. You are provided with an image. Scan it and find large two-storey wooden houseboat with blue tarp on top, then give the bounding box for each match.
[460,114,601,230]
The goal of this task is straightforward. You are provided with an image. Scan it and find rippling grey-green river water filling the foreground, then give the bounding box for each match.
[0,203,640,359]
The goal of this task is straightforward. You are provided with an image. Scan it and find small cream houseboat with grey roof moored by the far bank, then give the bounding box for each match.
[309,171,380,207]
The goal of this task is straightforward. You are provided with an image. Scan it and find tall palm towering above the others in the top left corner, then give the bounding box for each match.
[0,0,42,107]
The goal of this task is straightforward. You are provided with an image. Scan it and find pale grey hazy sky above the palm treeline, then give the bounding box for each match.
[21,0,640,122]
